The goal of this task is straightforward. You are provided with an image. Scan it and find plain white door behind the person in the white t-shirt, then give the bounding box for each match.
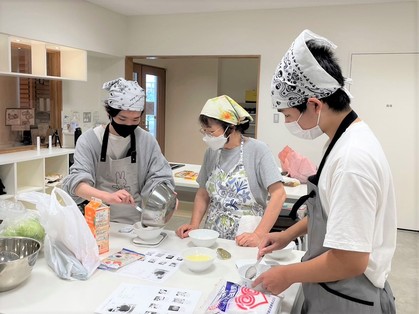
[350,53,419,230]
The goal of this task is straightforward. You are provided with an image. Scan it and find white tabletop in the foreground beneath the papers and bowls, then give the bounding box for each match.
[0,223,303,314]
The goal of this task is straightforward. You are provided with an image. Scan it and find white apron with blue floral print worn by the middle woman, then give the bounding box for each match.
[204,138,264,240]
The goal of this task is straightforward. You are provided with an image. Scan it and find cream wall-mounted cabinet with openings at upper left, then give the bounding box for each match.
[0,34,87,81]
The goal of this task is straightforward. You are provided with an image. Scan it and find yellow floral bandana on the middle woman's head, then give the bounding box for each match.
[201,95,253,125]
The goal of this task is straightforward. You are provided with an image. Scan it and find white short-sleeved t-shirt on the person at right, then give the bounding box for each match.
[319,122,397,288]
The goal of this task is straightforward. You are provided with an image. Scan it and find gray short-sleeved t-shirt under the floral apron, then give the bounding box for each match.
[196,138,283,208]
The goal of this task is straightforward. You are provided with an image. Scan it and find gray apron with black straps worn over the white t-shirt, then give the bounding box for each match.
[292,111,396,314]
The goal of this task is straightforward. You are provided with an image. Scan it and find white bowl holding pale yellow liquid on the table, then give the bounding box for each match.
[182,247,216,272]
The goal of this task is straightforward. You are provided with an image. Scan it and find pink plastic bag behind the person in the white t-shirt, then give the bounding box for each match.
[278,146,317,183]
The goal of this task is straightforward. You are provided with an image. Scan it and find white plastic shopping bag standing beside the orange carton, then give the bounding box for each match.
[17,188,100,280]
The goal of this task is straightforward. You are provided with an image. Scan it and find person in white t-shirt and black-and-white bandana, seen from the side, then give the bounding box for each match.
[253,30,397,314]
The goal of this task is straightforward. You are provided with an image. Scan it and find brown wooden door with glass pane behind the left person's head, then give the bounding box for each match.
[132,63,166,154]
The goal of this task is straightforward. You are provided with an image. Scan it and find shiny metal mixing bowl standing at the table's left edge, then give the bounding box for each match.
[0,237,41,292]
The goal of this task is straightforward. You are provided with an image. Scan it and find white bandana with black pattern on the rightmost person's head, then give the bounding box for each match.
[271,29,352,109]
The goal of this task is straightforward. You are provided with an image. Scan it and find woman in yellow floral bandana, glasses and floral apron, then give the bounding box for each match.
[176,95,286,246]
